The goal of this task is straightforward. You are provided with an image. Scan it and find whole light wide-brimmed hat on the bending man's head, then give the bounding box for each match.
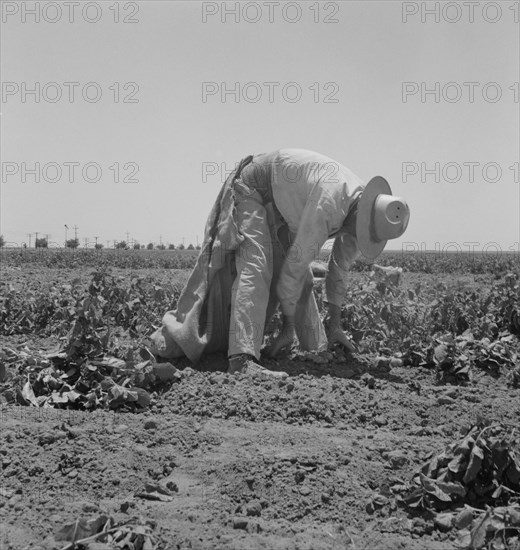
[356,176,410,260]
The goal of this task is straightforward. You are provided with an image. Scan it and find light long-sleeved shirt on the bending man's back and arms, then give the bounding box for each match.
[268,149,364,315]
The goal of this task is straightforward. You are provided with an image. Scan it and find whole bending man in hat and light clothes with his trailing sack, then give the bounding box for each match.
[152,149,409,376]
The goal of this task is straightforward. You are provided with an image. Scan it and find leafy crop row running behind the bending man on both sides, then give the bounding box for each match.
[0,270,520,384]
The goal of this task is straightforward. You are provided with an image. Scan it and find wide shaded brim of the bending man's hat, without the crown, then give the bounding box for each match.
[356,176,392,260]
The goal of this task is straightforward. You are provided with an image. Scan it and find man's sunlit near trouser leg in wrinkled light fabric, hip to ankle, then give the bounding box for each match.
[228,181,273,359]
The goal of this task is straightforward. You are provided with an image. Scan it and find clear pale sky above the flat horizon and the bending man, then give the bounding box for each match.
[0,0,520,250]
